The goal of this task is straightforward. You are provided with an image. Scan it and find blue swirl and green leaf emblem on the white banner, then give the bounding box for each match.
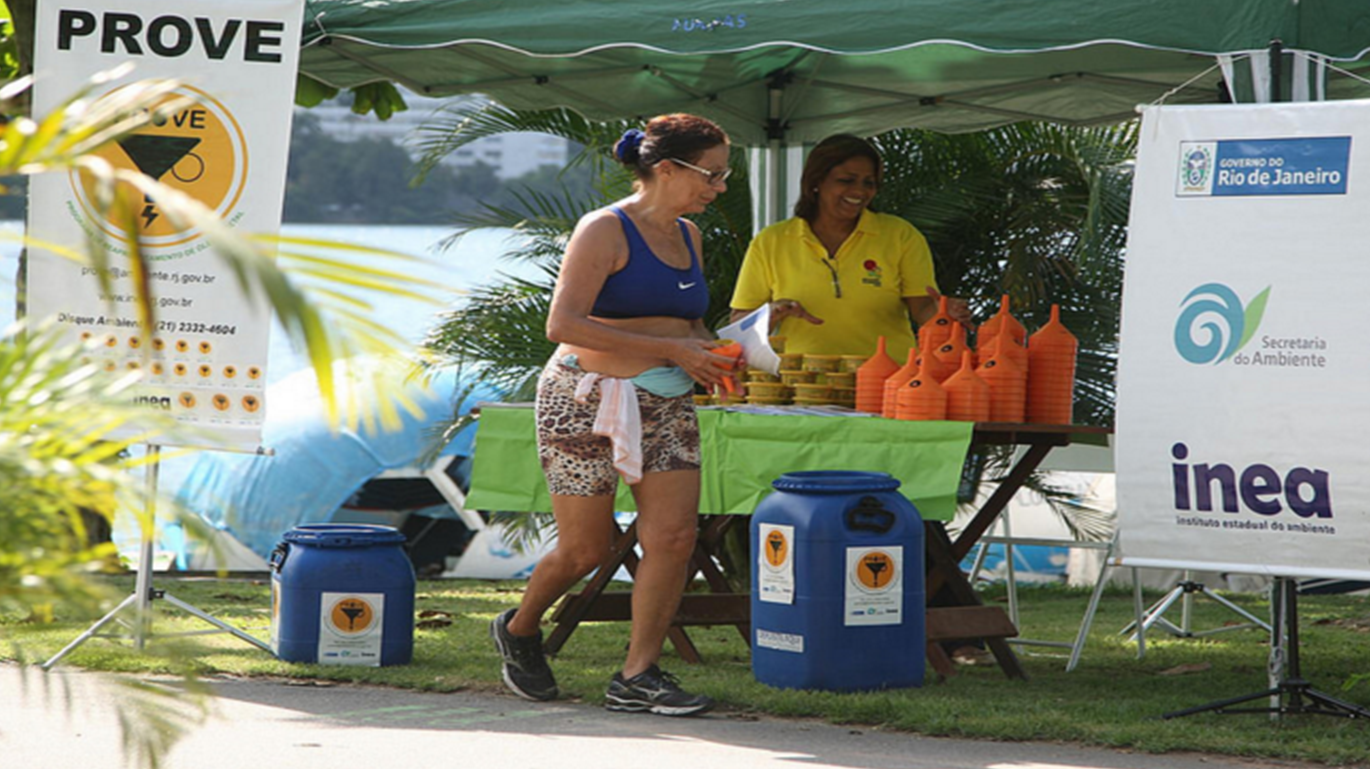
[1175,282,1270,365]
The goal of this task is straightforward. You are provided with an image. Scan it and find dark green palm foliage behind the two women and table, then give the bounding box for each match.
[421,104,1136,536]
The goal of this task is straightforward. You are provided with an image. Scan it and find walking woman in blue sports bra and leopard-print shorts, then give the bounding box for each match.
[490,114,732,716]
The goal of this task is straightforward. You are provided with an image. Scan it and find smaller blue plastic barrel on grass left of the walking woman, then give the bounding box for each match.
[271,524,414,666]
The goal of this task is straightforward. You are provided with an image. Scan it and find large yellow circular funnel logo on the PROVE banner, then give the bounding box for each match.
[71,85,248,248]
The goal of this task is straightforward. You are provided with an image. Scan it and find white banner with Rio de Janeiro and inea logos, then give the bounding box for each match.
[1117,101,1370,578]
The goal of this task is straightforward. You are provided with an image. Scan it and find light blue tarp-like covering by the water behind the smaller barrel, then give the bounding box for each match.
[175,363,499,558]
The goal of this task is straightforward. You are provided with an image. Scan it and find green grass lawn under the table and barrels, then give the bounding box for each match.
[8,577,1370,765]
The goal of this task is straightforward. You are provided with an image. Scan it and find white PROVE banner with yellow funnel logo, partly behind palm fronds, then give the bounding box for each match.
[27,0,304,448]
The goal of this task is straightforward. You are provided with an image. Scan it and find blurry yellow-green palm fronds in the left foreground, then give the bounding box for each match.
[0,70,437,766]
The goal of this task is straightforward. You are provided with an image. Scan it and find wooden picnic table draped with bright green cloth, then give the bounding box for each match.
[470,404,1112,679]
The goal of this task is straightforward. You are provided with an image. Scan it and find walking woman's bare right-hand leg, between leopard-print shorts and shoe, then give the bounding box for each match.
[623,470,699,679]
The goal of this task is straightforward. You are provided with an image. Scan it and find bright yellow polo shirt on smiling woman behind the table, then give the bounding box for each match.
[732,211,937,365]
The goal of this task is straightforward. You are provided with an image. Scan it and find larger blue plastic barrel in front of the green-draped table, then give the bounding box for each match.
[751,472,926,691]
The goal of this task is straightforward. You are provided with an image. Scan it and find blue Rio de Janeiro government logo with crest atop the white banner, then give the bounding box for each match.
[1175,136,1351,197]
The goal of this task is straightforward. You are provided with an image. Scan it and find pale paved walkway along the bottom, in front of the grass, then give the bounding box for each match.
[0,665,1320,769]
